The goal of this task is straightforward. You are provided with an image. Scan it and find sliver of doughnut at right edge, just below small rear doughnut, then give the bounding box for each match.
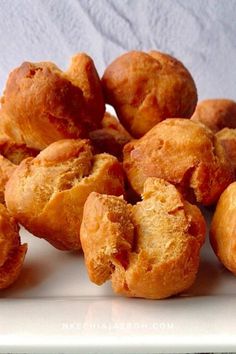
[216,128,236,176]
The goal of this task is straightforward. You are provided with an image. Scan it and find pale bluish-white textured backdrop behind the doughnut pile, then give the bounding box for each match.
[0,0,236,99]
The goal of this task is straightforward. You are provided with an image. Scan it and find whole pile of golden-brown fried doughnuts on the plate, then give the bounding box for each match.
[0,51,236,299]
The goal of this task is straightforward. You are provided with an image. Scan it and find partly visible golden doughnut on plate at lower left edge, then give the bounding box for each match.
[0,204,27,289]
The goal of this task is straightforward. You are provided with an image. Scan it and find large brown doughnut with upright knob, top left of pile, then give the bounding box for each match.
[0,54,105,150]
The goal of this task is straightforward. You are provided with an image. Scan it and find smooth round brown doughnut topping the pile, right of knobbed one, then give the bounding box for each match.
[102,51,197,138]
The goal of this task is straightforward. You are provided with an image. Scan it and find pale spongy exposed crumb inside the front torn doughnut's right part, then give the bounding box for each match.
[133,181,188,264]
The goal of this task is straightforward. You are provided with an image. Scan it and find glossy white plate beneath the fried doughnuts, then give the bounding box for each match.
[0,207,236,354]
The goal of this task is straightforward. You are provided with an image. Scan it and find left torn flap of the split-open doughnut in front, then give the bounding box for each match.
[82,194,134,284]
